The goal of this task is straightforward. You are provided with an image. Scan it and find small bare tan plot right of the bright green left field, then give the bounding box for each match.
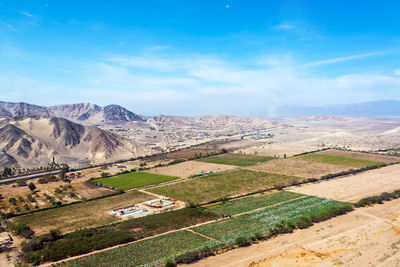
[149,161,237,178]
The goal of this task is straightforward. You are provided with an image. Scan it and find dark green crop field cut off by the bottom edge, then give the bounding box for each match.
[57,231,218,267]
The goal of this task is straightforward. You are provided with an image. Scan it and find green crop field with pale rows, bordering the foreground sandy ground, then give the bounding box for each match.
[193,196,344,244]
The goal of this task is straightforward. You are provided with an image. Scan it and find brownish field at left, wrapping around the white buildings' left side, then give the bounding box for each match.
[12,191,154,234]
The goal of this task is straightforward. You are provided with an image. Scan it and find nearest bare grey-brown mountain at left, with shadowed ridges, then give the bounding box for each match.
[0,117,143,167]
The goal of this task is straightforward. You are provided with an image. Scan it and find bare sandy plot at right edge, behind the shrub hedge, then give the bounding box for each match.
[287,164,400,202]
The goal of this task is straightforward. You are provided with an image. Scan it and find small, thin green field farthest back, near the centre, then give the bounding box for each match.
[198,153,275,166]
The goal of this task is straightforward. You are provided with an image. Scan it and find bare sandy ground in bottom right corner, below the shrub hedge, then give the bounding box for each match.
[188,199,400,267]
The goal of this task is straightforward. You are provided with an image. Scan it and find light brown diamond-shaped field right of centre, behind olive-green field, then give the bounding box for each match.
[246,158,351,178]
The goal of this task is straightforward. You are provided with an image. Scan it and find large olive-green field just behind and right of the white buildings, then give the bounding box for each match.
[149,169,302,203]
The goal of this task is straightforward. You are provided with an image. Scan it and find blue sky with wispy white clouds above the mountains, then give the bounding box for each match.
[0,0,400,117]
